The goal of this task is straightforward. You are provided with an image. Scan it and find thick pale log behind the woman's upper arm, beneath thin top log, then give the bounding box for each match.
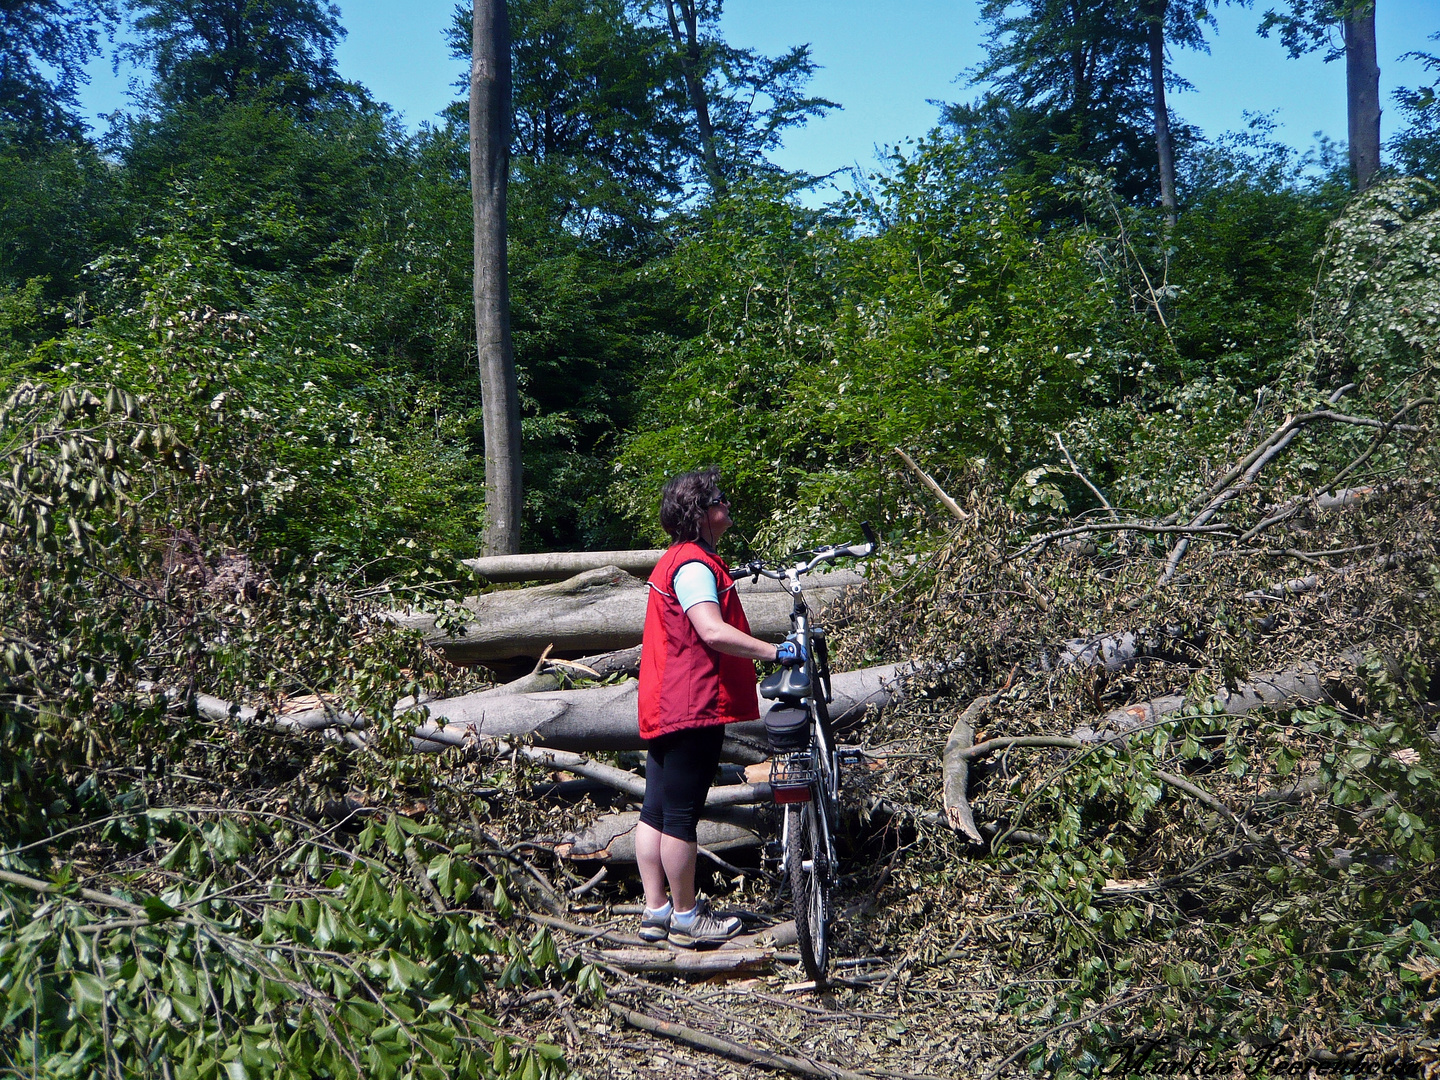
[395,566,864,665]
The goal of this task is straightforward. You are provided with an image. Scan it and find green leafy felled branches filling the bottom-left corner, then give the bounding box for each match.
[0,809,564,1080]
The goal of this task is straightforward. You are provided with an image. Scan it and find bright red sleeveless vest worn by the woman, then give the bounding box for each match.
[639,541,760,739]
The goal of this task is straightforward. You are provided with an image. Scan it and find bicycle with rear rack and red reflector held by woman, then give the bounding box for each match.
[744,521,880,988]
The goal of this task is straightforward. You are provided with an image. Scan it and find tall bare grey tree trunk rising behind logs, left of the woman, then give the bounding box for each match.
[469,0,521,554]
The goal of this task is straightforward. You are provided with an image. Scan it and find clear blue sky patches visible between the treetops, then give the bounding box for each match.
[82,0,1440,182]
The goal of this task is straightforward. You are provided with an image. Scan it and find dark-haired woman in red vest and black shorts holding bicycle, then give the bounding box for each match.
[635,468,799,948]
